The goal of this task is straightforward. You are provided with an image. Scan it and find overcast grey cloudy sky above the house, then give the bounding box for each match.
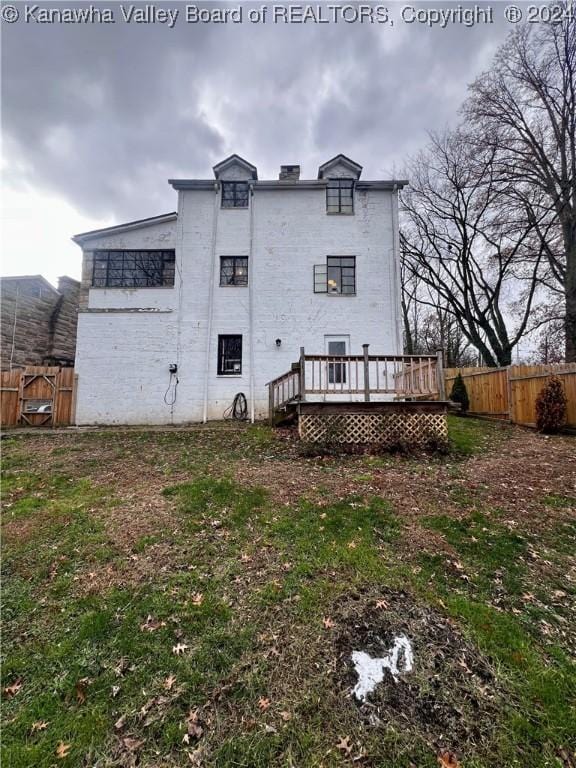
[1,0,509,282]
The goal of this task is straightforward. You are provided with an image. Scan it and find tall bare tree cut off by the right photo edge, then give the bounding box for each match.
[464,8,576,362]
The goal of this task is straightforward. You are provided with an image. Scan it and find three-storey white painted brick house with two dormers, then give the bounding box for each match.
[74,155,405,424]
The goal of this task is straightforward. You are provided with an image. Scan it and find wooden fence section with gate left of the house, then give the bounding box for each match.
[0,366,76,427]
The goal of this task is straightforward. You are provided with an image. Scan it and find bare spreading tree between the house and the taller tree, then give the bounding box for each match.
[401,131,544,366]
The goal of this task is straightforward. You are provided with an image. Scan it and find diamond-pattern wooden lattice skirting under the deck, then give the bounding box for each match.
[298,413,448,446]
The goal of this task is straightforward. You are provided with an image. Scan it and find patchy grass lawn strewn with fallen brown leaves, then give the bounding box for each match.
[2,418,576,768]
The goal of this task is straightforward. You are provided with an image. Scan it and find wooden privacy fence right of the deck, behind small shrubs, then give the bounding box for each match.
[445,363,576,427]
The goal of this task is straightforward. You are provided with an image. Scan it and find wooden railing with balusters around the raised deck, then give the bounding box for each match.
[268,344,445,417]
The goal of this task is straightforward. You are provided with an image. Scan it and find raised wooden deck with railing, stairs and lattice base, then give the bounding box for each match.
[268,345,448,445]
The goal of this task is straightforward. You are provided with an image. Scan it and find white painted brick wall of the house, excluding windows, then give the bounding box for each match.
[76,178,401,424]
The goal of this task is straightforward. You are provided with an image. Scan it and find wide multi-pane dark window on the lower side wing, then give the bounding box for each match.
[92,250,176,288]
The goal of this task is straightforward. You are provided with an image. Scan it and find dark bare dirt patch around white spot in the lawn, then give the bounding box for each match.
[333,589,502,753]
